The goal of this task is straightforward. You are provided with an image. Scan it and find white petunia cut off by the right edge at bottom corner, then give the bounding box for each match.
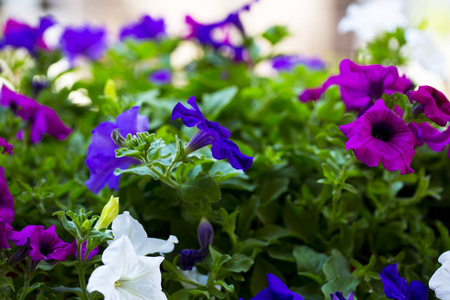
[428,251,450,300]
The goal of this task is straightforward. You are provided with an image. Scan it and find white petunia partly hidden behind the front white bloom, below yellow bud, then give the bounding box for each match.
[108,211,178,255]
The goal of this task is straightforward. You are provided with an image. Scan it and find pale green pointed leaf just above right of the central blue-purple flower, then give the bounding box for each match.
[202,86,238,120]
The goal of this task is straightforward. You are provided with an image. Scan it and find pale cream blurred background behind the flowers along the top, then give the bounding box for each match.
[0,0,352,60]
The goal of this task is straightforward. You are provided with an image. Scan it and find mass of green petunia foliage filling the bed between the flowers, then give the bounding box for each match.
[0,21,450,300]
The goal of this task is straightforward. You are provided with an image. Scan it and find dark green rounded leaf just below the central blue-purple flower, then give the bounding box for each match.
[178,175,222,203]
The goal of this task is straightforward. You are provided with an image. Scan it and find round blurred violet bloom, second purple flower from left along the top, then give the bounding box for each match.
[60,25,108,64]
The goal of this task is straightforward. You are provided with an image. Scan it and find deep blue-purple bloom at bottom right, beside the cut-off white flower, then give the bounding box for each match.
[380,264,428,300]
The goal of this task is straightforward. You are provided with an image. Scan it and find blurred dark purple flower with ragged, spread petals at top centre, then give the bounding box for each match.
[185,0,258,62]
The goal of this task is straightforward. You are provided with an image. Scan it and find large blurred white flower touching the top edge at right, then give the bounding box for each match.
[338,0,408,42]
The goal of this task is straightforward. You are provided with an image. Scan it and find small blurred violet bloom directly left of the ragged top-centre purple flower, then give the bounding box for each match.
[120,16,166,41]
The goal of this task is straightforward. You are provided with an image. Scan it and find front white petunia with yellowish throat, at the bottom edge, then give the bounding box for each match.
[87,236,167,300]
